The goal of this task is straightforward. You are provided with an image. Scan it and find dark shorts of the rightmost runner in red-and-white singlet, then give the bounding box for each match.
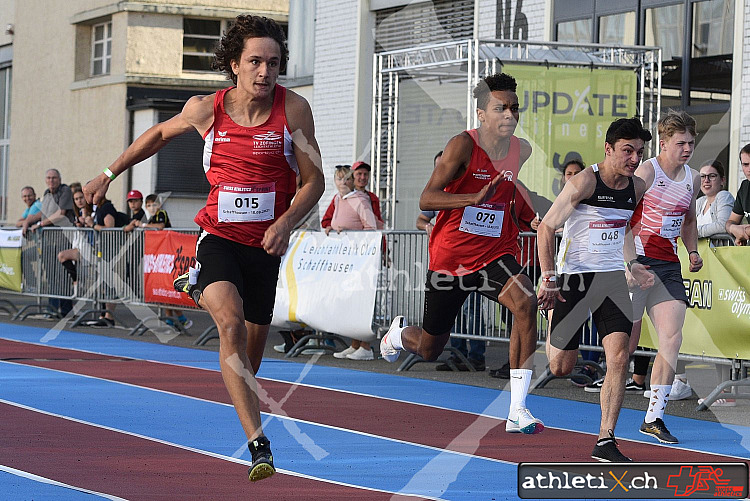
[633,256,688,320]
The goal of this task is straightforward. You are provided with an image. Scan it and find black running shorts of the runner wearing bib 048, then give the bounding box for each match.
[549,271,633,350]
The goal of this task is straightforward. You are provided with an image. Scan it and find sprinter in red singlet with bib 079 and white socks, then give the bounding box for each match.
[380,74,544,434]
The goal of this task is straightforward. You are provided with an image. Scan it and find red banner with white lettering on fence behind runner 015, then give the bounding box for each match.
[143,231,198,307]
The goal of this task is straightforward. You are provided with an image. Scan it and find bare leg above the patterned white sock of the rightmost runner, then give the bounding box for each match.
[649,300,687,385]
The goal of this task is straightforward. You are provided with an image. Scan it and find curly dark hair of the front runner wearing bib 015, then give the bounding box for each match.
[216,15,289,84]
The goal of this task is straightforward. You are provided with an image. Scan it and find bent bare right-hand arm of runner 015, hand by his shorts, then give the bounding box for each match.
[261,91,325,256]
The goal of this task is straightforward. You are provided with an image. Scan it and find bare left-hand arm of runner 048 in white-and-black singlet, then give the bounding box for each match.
[537,167,596,310]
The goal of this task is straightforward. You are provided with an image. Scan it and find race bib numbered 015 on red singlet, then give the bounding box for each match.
[218,183,276,223]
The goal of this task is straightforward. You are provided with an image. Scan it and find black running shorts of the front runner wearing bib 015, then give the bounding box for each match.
[196,232,281,325]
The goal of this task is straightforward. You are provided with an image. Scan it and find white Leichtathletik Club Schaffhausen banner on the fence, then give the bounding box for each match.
[271,231,382,341]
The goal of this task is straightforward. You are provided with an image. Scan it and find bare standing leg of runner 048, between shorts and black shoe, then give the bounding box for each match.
[599,332,630,438]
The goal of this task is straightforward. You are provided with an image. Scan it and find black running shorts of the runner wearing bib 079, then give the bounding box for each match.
[422,255,522,336]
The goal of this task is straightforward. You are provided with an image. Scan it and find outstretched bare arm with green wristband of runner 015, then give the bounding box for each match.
[83,94,215,204]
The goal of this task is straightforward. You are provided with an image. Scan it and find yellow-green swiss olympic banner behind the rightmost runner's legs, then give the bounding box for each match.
[639,239,750,360]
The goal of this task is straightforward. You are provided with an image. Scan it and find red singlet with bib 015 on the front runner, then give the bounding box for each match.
[195,88,299,247]
